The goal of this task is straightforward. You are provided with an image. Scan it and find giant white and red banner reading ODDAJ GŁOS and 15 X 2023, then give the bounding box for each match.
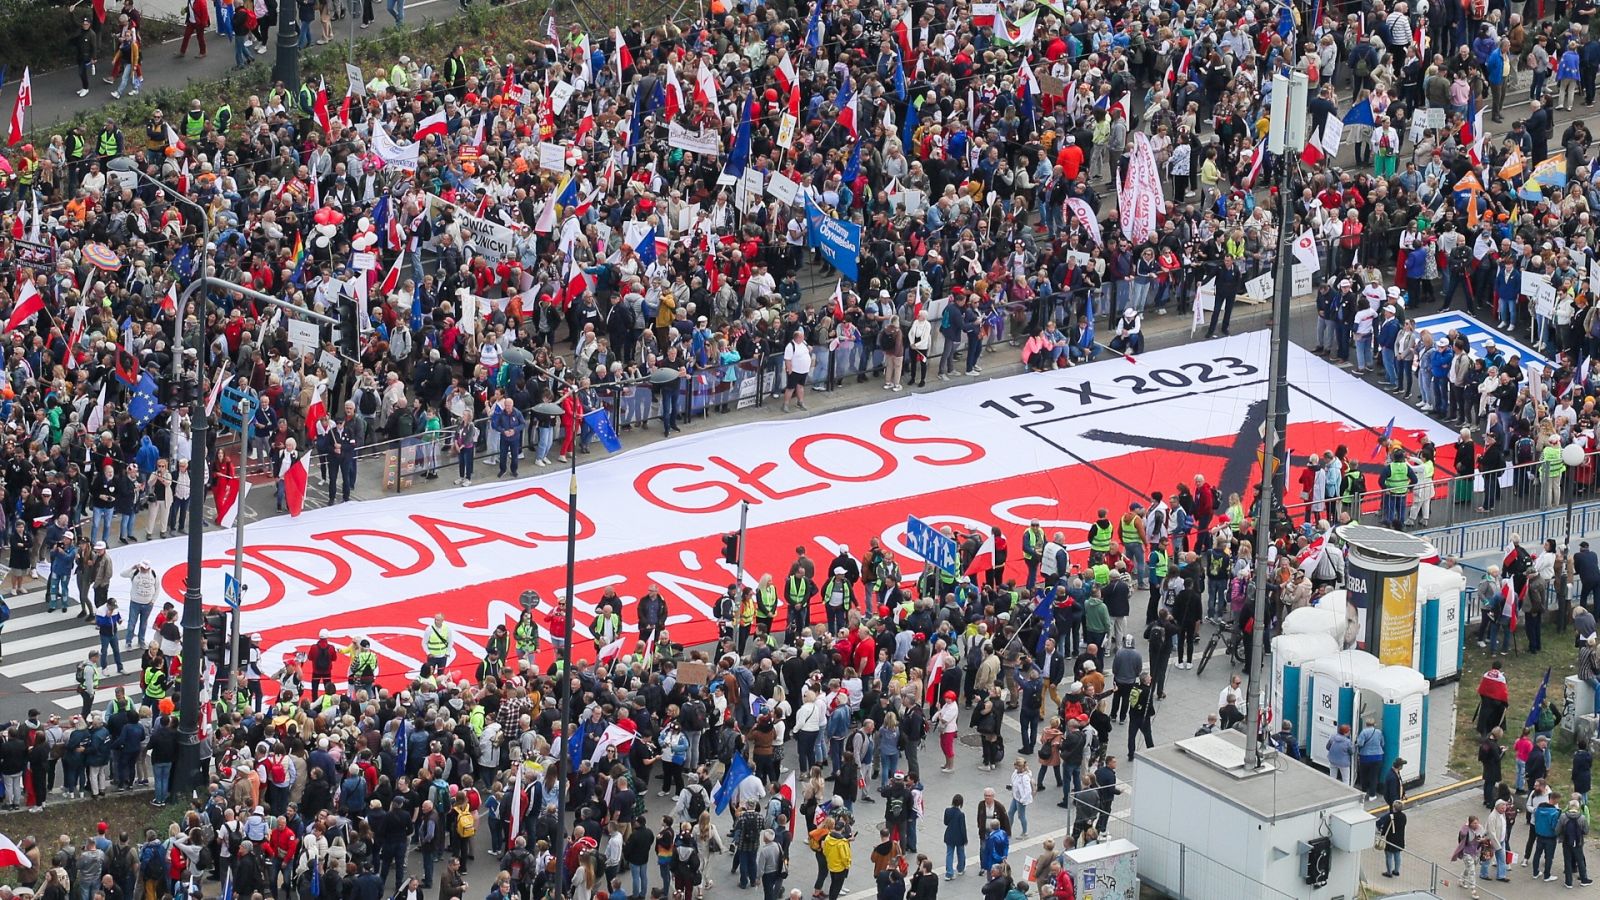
[114,331,1453,677]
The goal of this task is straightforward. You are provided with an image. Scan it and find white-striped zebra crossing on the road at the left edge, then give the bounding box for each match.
[0,586,142,713]
